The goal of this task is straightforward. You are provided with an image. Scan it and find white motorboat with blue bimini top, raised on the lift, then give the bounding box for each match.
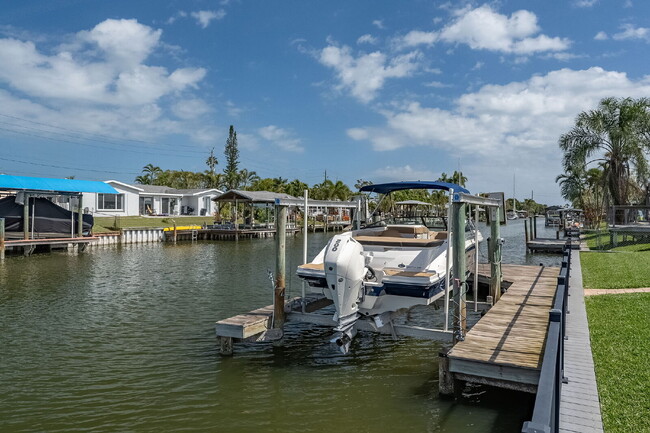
[297,181,482,353]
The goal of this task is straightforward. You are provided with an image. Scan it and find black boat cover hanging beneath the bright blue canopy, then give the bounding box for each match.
[0,196,93,235]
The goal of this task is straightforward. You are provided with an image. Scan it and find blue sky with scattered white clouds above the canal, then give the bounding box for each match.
[0,0,650,204]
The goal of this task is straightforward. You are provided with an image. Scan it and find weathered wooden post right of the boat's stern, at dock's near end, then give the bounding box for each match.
[451,202,467,343]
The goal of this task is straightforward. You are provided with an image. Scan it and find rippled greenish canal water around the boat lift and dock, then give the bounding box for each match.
[0,221,558,433]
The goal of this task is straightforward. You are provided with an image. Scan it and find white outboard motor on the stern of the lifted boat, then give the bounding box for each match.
[324,235,367,353]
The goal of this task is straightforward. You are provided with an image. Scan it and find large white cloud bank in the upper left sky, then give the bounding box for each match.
[0,19,210,145]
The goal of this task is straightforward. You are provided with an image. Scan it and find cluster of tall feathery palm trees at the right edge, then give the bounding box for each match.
[556,98,650,227]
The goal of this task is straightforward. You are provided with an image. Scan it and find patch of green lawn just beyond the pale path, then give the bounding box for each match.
[580,252,650,289]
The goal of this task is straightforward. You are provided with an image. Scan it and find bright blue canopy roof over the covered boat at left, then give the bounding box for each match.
[0,174,118,194]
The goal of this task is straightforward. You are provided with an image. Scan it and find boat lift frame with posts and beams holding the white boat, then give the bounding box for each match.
[216,184,502,355]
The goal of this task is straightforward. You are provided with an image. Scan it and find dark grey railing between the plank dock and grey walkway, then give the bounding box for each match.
[521,243,571,433]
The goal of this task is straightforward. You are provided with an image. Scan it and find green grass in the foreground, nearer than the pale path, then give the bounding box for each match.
[581,292,650,433]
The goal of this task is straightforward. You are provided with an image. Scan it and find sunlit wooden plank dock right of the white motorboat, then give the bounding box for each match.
[446,265,559,392]
